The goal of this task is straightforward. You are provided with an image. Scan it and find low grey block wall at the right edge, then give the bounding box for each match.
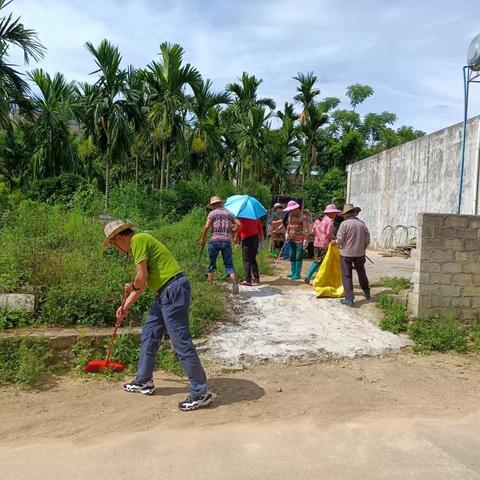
[408,213,480,318]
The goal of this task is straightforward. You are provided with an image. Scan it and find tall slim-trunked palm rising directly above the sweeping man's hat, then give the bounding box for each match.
[83,40,139,209]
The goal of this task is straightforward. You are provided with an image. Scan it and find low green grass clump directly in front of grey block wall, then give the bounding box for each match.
[407,317,468,353]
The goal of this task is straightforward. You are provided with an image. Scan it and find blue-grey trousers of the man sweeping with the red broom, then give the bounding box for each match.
[135,275,207,396]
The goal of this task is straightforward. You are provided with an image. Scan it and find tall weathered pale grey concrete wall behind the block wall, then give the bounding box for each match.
[347,116,480,247]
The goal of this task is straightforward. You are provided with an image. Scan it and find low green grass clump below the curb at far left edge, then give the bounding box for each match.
[0,337,53,389]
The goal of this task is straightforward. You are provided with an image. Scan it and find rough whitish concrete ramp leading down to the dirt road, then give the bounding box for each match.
[209,285,412,365]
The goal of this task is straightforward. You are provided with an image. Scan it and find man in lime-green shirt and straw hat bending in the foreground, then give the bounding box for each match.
[104,220,213,411]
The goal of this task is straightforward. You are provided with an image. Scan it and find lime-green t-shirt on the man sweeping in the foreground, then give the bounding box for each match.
[130,233,182,293]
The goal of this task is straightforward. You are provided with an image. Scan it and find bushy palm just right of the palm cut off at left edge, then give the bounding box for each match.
[28,69,78,178]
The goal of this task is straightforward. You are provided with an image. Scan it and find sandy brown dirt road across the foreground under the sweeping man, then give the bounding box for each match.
[0,253,480,480]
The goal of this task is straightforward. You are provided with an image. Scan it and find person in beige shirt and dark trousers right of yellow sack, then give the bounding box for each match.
[332,203,371,306]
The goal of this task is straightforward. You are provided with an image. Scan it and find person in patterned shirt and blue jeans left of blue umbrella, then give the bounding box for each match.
[200,197,241,295]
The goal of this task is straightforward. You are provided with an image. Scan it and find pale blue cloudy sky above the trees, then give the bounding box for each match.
[6,0,480,132]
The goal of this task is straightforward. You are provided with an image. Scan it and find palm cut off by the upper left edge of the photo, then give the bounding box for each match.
[0,0,45,128]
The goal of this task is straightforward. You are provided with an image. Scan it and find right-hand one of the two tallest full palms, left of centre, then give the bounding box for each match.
[145,42,201,189]
